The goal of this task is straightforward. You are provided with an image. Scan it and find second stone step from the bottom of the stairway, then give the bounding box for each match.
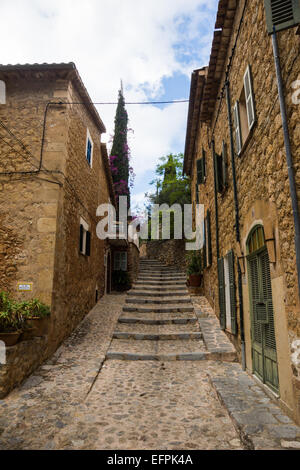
[115,322,200,335]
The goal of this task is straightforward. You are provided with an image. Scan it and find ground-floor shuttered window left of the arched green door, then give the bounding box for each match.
[218,251,237,335]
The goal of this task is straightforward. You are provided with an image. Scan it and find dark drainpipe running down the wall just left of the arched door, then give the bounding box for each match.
[226,80,246,370]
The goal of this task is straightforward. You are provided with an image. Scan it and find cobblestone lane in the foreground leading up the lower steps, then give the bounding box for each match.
[0,260,300,450]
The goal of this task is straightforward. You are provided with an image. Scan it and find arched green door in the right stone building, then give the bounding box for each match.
[248,227,279,392]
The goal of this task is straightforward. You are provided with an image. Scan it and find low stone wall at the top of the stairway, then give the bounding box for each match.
[141,240,186,271]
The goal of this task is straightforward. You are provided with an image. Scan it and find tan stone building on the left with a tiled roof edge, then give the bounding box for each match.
[0,63,138,394]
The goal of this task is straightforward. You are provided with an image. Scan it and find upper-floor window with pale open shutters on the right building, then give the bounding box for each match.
[234,65,256,155]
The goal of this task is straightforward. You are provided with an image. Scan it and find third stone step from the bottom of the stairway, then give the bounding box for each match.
[119,314,198,326]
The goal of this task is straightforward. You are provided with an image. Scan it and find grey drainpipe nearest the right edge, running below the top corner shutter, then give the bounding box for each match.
[272,27,300,302]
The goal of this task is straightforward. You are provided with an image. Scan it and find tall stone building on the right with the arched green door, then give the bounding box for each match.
[184,0,300,422]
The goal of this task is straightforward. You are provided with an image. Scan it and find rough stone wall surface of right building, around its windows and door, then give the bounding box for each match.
[191,0,300,419]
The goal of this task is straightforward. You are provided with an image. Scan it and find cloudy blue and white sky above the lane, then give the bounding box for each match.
[0,0,218,210]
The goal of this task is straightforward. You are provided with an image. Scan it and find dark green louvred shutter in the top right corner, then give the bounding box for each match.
[265,0,300,34]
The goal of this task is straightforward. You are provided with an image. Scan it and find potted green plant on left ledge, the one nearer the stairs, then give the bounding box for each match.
[19,299,50,336]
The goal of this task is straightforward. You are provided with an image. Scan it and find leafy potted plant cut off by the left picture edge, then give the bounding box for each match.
[0,292,24,347]
